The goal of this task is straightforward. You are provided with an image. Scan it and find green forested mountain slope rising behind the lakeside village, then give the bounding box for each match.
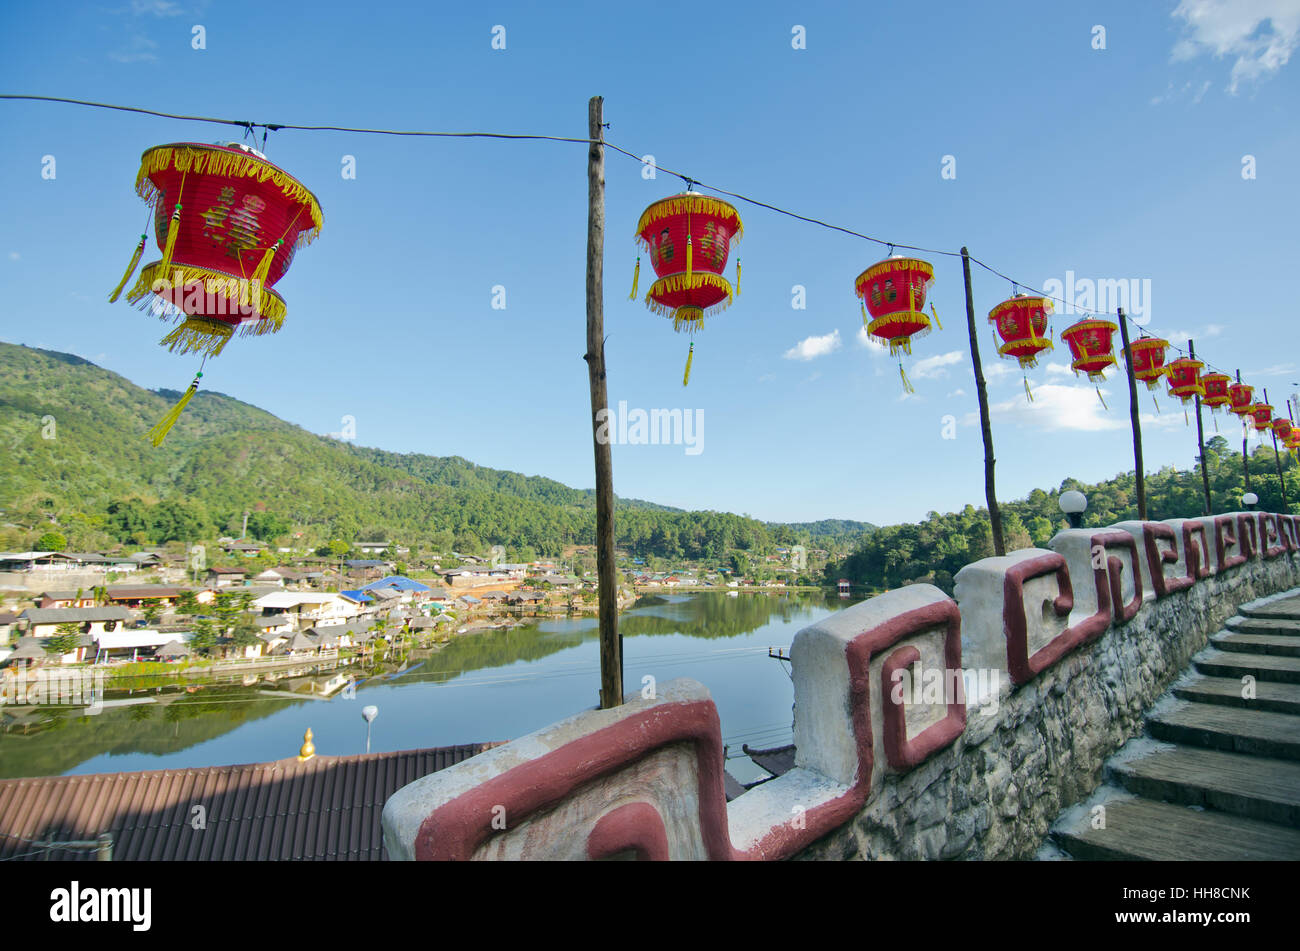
[0,343,861,560]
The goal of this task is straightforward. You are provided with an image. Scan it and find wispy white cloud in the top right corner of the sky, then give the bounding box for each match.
[1171,0,1300,95]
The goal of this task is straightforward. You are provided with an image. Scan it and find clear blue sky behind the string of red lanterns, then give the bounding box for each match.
[0,0,1300,522]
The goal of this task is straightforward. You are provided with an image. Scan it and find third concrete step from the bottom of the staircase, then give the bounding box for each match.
[1147,700,1300,760]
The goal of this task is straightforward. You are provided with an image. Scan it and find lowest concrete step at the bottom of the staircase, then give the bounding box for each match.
[1052,799,1300,861]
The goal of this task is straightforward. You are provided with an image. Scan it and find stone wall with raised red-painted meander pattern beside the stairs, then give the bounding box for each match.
[384,513,1300,860]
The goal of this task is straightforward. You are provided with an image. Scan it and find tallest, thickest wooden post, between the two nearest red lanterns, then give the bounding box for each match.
[582,96,623,709]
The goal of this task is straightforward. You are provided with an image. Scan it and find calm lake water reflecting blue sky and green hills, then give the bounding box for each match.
[0,592,852,781]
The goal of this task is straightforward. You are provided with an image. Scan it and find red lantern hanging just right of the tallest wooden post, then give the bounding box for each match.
[631,191,745,386]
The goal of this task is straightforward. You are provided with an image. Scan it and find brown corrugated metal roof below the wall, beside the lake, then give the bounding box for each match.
[0,743,497,861]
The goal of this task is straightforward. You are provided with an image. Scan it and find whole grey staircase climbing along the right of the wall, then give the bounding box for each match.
[1043,594,1300,860]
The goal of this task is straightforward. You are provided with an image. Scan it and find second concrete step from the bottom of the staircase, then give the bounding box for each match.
[1108,746,1300,829]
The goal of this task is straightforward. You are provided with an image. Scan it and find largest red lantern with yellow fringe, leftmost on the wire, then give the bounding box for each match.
[109,142,321,446]
